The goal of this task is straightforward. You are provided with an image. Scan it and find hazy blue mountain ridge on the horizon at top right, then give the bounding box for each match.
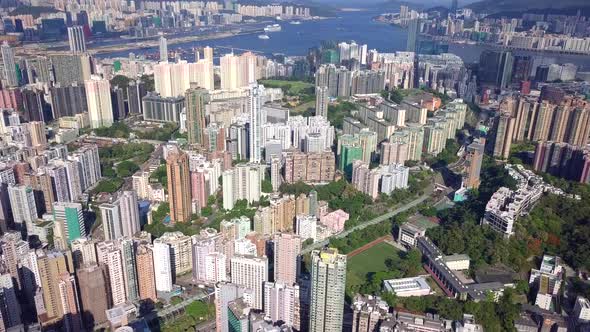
[465,0,590,14]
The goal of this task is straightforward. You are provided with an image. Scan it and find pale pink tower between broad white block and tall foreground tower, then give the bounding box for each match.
[273,233,301,285]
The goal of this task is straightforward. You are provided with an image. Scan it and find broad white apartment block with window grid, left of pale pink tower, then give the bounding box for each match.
[231,256,268,309]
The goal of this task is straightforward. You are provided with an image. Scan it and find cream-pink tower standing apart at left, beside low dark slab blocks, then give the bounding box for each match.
[84,76,113,128]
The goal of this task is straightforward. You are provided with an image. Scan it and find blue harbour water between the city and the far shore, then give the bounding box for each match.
[99,10,590,71]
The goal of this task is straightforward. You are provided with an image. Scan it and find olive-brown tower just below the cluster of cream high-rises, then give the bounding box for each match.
[185,88,208,146]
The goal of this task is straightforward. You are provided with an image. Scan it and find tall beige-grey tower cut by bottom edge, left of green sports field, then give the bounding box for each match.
[309,248,346,332]
